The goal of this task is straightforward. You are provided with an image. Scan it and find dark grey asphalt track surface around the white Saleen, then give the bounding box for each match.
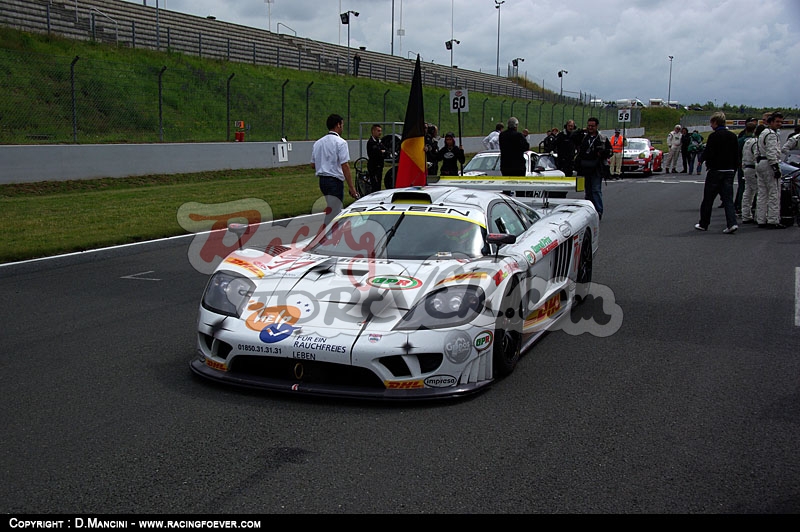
[0,174,800,516]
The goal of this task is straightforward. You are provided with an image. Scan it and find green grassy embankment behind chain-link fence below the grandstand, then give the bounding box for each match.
[0,45,640,144]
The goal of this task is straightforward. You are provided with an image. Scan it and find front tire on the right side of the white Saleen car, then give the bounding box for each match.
[492,278,523,377]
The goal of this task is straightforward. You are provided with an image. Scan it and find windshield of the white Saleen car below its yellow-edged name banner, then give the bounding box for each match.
[307,212,486,260]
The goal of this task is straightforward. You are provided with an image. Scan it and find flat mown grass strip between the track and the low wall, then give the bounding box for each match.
[0,166,332,262]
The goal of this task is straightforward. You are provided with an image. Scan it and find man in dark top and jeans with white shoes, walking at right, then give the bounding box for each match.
[694,111,739,235]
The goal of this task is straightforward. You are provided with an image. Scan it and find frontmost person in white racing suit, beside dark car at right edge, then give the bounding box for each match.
[756,112,786,229]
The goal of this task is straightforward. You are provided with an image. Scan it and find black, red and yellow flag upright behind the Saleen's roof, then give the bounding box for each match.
[395,54,428,188]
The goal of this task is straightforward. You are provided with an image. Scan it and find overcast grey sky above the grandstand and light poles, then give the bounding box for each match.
[131,0,800,109]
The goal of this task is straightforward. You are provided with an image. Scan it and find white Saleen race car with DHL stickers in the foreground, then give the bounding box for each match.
[190,186,599,400]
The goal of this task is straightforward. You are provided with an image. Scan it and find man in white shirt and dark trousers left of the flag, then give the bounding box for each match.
[311,113,358,225]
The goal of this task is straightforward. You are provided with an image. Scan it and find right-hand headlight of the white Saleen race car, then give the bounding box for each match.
[395,285,486,330]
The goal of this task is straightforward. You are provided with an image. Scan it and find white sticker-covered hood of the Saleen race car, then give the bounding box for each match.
[219,249,503,331]
